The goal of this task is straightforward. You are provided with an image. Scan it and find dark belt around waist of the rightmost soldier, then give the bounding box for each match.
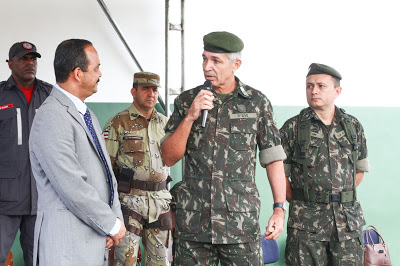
[292,189,355,204]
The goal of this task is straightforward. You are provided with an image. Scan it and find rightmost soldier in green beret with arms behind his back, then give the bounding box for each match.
[280,63,369,266]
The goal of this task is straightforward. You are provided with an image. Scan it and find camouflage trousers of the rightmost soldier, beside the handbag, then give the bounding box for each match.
[285,231,364,266]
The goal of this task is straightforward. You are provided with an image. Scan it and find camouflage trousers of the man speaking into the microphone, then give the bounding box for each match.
[173,238,264,266]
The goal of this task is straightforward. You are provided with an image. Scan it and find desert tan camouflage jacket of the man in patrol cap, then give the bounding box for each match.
[103,104,169,182]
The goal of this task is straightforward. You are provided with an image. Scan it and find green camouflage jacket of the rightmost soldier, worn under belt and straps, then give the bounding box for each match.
[280,107,369,241]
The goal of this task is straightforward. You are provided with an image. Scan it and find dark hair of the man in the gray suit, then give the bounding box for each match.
[54,39,92,83]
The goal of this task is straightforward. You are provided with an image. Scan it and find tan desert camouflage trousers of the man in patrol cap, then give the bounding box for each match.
[114,189,171,266]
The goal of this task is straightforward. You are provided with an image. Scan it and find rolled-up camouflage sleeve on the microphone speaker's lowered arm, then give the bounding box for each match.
[257,96,286,167]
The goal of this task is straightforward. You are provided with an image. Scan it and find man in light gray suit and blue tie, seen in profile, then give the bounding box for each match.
[29,39,126,266]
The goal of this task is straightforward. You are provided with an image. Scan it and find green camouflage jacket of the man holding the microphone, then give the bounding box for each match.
[166,78,286,244]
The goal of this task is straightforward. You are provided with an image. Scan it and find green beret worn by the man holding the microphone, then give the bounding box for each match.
[203,31,244,53]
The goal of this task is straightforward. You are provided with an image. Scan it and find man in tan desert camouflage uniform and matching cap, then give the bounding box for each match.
[104,72,174,265]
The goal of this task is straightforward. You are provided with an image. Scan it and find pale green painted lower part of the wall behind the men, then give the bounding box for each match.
[12,103,400,266]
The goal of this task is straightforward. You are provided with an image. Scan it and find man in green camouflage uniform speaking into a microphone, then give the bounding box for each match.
[161,32,286,266]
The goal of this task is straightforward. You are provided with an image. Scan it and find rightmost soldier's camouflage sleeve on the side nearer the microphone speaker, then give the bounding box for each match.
[279,119,296,177]
